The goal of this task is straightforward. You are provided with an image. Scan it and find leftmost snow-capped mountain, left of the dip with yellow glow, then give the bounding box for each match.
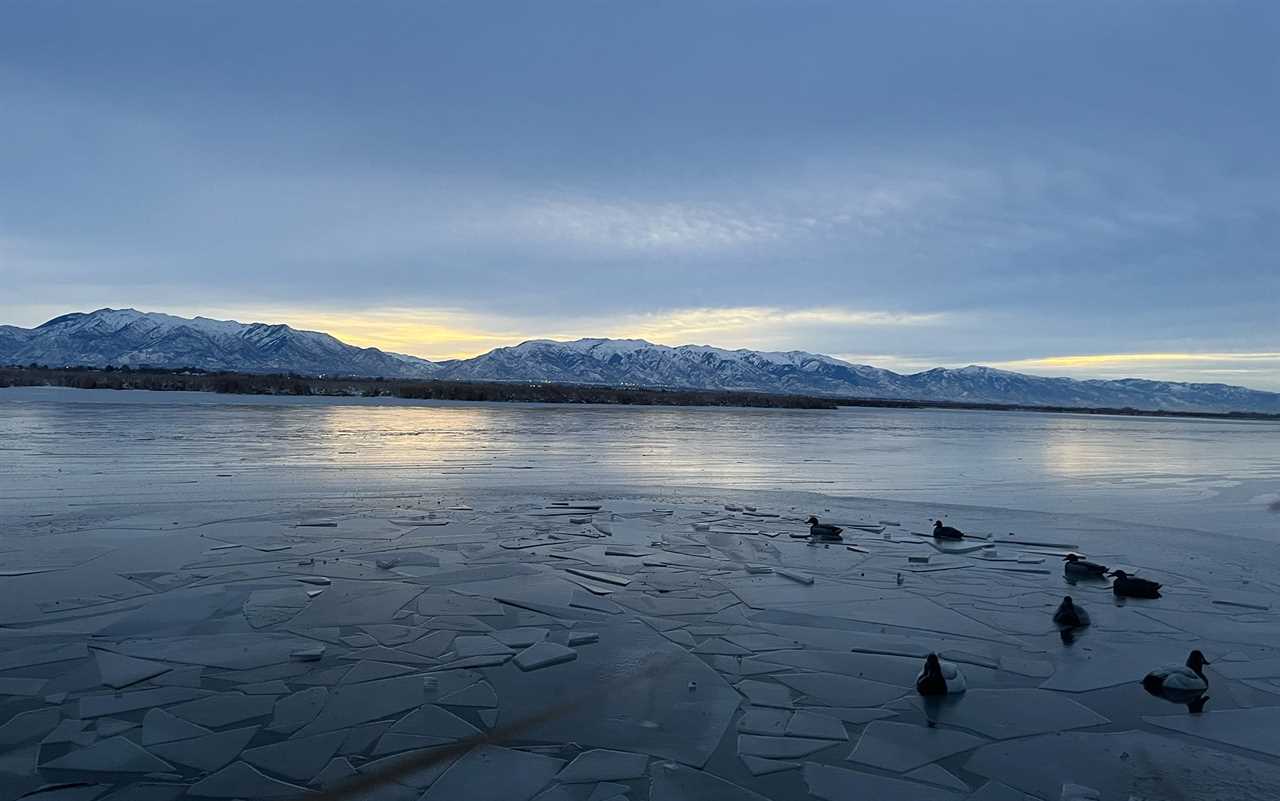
[0,308,434,377]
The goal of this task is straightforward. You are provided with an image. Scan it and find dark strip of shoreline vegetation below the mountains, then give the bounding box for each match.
[0,365,1280,421]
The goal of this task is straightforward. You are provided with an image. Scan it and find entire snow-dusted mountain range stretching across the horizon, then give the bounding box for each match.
[0,308,1280,413]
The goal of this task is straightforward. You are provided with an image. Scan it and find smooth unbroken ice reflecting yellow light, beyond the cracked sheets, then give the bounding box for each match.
[0,389,1280,541]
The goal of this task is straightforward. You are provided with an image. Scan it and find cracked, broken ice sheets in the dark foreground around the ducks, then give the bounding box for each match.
[0,394,1280,801]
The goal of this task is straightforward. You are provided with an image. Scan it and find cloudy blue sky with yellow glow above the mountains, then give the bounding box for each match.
[0,0,1280,390]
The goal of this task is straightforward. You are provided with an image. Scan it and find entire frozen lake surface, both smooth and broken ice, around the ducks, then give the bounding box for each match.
[0,389,1280,801]
